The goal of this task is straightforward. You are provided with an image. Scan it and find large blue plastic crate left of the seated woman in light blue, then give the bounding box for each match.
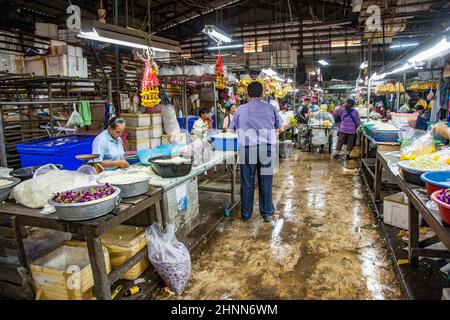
[16,135,95,170]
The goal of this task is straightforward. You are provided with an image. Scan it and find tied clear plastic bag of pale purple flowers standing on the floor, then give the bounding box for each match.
[145,223,191,295]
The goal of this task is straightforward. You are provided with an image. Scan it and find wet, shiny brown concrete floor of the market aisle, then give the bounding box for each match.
[156,151,404,299]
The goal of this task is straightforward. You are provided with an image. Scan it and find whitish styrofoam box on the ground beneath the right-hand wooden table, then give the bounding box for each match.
[383,192,409,230]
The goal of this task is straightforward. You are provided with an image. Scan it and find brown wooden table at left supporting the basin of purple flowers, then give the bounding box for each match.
[0,188,163,300]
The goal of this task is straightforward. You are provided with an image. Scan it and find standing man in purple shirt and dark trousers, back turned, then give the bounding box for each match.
[229,81,282,222]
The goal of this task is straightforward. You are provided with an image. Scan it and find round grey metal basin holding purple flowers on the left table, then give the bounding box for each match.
[48,185,122,221]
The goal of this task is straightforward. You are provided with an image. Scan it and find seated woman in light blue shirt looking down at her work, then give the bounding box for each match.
[92,117,129,170]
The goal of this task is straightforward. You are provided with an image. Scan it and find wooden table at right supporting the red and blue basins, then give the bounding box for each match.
[374,151,450,266]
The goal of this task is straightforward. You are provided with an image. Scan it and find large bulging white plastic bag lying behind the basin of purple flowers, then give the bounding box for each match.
[11,166,97,209]
